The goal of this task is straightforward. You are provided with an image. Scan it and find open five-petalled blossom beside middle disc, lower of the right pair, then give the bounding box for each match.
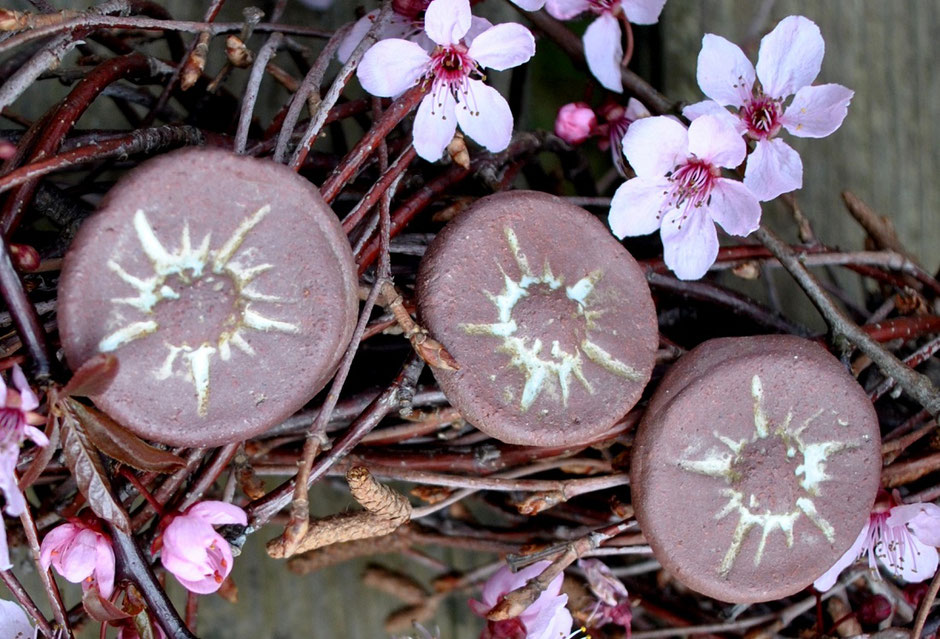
[610,115,761,280]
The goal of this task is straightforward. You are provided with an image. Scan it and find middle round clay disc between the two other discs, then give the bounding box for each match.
[417,191,659,446]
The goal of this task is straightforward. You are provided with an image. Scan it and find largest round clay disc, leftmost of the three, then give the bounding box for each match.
[59,149,358,446]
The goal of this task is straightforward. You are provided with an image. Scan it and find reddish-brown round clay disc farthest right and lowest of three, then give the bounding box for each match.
[630,335,881,603]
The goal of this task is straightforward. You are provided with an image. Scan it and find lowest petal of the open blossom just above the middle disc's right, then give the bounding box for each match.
[659,208,718,280]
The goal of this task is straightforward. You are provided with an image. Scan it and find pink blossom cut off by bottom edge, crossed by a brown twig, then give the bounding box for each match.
[470,561,572,639]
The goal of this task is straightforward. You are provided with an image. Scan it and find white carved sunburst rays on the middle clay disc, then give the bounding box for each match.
[460,226,644,411]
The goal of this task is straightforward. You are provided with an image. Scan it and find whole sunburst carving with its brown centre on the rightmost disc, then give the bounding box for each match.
[679,375,855,577]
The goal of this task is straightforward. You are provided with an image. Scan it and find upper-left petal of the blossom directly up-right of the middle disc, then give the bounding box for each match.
[623,115,689,179]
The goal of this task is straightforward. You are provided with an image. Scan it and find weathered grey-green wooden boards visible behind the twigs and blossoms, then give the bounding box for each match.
[0,0,940,639]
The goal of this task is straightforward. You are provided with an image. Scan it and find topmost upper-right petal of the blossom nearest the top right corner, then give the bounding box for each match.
[757,16,826,99]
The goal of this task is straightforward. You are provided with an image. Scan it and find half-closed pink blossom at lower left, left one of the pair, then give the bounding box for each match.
[39,519,114,598]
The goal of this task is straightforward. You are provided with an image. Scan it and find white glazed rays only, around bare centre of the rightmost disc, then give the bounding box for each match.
[679,375,855,577]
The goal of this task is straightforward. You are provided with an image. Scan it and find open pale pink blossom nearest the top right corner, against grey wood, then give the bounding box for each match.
[683,16,855,201]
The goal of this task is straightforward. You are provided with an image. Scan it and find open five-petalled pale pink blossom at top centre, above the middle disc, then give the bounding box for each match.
[357,0,535,162]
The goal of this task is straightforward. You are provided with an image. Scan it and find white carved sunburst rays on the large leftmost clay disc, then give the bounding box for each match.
[98,205,300,416]
